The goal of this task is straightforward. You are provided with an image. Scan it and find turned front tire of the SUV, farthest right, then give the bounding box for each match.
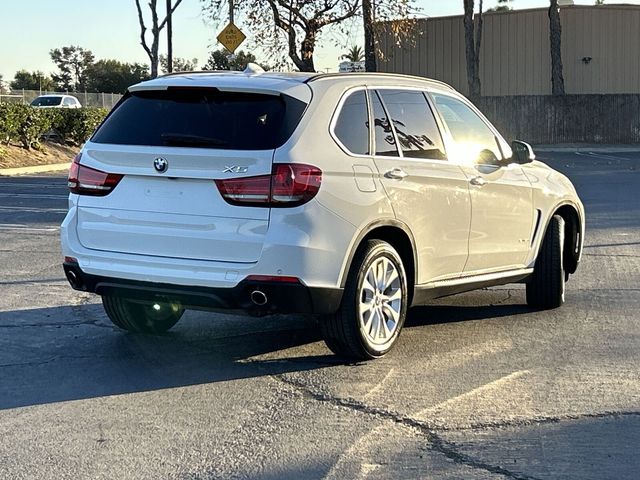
[527,215,566,309]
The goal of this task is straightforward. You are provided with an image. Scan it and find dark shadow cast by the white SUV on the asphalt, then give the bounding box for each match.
[0,301,530,409]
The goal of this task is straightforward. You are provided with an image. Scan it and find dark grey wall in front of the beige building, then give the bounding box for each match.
[476,95,640,145]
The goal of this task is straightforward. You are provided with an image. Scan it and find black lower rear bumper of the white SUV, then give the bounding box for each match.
[63,262,342,315]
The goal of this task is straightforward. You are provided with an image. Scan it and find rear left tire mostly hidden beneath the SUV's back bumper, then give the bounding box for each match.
[102,296,184,334]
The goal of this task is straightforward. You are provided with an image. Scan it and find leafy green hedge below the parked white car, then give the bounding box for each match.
[0,103,108,149]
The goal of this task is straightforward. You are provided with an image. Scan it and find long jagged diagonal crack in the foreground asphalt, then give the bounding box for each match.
[272,375,537,480]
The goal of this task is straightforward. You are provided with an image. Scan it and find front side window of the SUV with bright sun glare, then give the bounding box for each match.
[433,94,502,163]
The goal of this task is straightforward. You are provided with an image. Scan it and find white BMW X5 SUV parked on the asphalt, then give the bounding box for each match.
[61,71,585,359]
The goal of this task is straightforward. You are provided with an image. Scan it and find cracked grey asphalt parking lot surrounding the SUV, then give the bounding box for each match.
[0,151,640,479]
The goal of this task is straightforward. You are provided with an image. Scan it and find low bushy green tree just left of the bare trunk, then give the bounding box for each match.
[85,59,149,93]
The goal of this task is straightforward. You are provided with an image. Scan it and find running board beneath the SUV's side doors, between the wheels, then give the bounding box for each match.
[411,268,533,306]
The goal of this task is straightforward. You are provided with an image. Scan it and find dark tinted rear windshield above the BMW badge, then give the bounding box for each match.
[91,88,306,150]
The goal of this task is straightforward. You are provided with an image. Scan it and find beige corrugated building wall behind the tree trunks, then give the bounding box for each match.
[379,5,640,96]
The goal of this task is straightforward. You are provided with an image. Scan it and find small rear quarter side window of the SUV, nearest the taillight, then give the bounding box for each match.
[334,90,369,155]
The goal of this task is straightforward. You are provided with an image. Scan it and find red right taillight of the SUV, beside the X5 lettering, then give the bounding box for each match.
[215,163,322,207]
